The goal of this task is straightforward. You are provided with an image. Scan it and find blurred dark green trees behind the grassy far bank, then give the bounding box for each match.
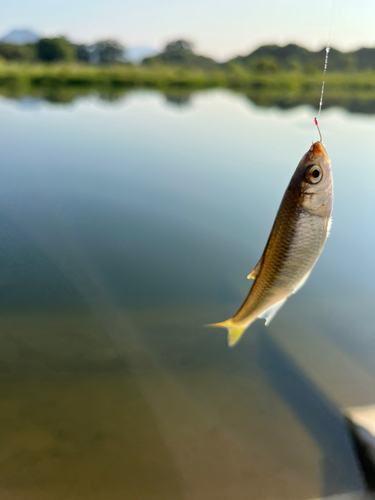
[0,37,375,74]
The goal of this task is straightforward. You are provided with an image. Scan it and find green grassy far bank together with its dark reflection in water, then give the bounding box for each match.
[0,64,375,113]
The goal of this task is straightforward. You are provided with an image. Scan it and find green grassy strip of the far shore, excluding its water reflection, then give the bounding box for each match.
[0,63,375,95]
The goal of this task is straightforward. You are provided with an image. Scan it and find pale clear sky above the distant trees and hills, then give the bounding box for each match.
[0,0,375,60]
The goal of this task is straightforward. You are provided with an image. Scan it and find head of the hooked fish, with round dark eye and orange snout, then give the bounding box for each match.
[292,142,333,217]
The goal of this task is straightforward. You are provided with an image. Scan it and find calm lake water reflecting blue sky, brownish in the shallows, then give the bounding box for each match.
[0,90,375,500]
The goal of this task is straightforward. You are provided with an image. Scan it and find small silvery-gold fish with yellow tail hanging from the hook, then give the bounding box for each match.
[208,142,333,346]
